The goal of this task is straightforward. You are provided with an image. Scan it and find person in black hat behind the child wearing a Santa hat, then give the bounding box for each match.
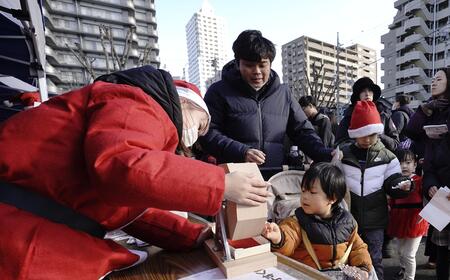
[335,77,399,152]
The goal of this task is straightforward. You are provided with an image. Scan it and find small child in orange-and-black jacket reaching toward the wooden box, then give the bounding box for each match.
[262,163,372,279]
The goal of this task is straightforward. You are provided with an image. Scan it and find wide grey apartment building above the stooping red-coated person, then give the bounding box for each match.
[43,0,159,93]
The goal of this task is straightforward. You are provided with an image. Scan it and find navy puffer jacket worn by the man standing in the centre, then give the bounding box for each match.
[200,61,331,167]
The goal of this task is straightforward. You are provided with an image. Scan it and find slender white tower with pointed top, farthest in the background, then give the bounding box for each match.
[186,0,227,93]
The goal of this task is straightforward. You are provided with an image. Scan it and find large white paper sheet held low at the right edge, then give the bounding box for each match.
[419,187,450,231]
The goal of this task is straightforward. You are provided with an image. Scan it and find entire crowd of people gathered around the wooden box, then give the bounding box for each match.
[0,30,450,280]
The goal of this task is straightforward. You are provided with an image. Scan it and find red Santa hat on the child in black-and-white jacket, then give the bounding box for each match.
[348,101,384,138]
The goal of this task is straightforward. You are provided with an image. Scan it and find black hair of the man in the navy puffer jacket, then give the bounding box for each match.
[233,30,276,62]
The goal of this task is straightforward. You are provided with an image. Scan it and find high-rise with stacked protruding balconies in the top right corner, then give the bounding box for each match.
[381,0,450,102]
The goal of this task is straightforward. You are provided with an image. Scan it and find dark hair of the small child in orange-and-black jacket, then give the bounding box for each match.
[301,162,347,207]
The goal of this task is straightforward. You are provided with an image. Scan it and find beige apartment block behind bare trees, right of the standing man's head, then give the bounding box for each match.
[281,36,377,105]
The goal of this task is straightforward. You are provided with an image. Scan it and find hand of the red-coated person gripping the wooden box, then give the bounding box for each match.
[224,171,270,206]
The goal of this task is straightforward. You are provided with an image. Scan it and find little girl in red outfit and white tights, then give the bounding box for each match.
[387,150,428,280]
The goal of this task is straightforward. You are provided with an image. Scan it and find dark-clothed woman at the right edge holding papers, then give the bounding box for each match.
[406,68,450,280]
